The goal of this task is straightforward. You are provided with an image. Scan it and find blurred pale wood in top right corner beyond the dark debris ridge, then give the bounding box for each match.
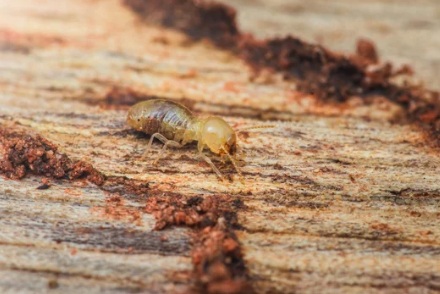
[223,0,440,91]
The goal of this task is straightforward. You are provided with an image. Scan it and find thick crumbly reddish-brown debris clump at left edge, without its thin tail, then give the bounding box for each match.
[0,126,105,185]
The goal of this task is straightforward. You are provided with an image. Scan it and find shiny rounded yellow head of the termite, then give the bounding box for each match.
[200,116,237,155]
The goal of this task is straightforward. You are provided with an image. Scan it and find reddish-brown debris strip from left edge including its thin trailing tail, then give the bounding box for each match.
[0,126,155,198]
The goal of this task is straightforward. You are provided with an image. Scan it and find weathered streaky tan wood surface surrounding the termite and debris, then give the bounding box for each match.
[0,0,440,293]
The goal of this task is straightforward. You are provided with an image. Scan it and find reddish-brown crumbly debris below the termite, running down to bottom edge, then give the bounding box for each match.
[145,194,253,293]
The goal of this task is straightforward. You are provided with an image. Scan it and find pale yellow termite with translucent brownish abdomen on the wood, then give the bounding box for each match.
[127,99,242,179]
